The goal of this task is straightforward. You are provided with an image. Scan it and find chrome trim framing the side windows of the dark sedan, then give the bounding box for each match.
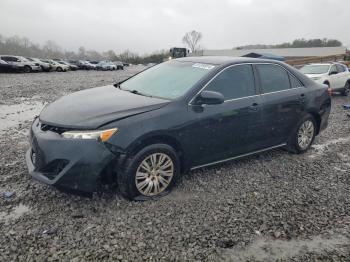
[188,62,306,106]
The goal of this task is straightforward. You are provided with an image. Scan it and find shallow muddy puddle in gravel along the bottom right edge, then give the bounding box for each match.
[220,235,350,262]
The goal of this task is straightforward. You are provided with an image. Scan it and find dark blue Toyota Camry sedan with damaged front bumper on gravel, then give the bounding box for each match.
[26,57,331,199]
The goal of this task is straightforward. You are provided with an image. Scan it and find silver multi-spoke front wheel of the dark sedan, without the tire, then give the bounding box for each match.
[135,153,174,196]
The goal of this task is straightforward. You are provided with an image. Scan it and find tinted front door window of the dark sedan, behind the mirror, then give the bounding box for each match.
[206,65,255,100]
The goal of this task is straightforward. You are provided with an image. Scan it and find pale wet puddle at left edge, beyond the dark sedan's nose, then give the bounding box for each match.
[0,102,44,133]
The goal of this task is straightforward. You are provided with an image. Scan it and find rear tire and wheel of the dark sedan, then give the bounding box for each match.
[287,114,317,154]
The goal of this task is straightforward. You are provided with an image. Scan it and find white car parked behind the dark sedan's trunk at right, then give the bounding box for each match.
[300,63,350,96]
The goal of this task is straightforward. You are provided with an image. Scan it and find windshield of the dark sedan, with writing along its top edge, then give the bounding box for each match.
[120,61,214,99]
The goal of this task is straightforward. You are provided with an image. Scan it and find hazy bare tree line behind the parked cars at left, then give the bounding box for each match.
[0,35,169,64]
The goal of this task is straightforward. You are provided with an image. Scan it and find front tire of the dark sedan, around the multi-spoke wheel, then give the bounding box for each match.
[117,144,180,200]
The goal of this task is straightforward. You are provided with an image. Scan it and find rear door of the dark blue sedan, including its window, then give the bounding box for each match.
[255,64,307,147]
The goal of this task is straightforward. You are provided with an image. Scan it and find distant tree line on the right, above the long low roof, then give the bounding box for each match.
[234,38,343,49]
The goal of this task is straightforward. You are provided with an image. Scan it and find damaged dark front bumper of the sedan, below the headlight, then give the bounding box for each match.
[26,118,117,192]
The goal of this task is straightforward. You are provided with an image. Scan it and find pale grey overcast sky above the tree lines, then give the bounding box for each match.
[0,0,350,54]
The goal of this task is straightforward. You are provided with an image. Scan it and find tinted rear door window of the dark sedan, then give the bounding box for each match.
[256,64,290,93]
